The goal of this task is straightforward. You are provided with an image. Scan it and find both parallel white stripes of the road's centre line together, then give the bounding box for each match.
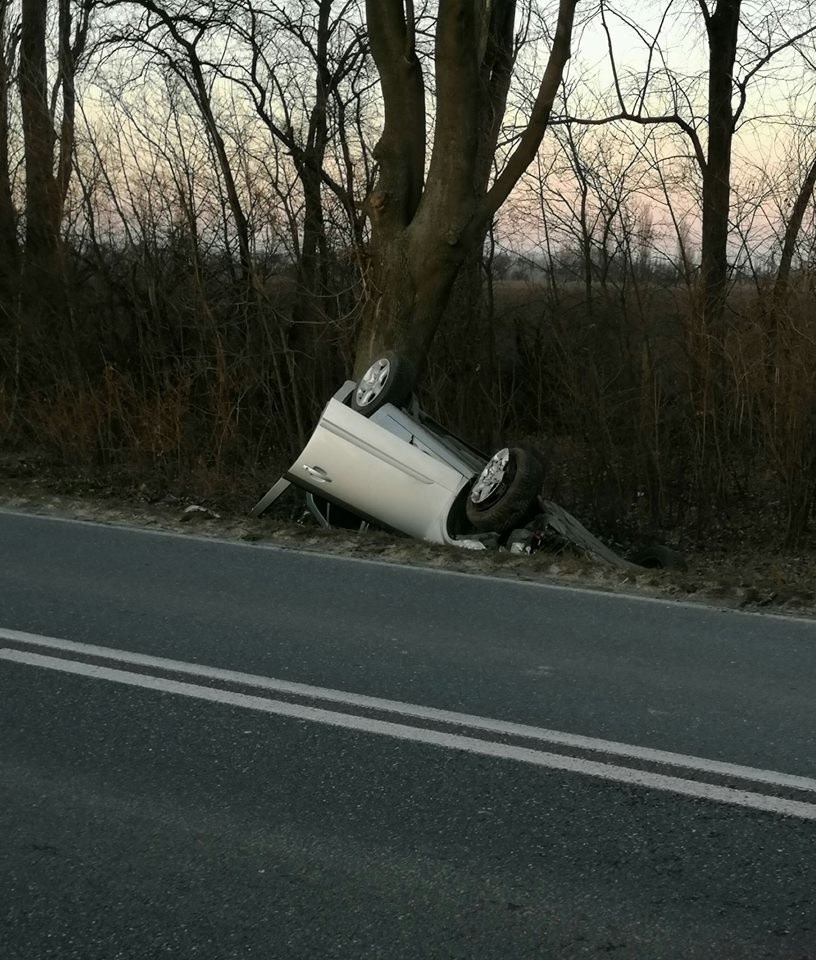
[0,629,816,820]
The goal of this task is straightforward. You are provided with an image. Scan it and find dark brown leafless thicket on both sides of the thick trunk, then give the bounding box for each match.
[0,243,816,544]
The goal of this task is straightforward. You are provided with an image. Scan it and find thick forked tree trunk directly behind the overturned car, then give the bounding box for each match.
[357,0,578,377]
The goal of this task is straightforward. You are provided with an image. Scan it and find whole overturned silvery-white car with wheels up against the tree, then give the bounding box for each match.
[252,353,544,546]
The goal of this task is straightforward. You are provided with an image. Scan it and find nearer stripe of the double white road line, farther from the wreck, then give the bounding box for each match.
[0,649,816,820]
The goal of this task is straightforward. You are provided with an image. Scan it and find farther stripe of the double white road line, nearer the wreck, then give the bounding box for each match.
[0,627,816,792]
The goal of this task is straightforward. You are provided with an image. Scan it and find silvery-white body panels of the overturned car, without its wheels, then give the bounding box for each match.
[252,380,487,546]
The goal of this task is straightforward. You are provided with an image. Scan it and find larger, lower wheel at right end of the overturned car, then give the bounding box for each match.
[465,447,544,534]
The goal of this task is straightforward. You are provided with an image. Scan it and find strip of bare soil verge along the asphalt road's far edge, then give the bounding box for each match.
[0,455,816,617]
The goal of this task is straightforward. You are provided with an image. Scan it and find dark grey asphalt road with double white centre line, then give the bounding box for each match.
[0,512,816,960]
